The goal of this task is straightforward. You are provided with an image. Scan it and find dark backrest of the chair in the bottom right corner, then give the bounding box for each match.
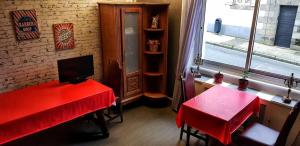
[275,101,300,146]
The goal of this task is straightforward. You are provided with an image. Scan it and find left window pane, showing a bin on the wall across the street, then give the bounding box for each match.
[203,0,254,68]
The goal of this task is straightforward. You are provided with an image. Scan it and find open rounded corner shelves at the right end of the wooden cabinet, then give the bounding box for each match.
[142,3,169,100]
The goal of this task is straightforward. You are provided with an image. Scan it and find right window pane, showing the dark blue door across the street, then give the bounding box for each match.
[251,0,300,78]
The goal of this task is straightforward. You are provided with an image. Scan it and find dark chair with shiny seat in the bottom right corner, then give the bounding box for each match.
[238,102,300,146]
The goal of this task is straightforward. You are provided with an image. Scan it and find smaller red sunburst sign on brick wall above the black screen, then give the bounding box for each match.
[53,23,75,50]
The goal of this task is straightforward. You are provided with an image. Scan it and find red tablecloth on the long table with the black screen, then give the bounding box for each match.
[0,80,115,145]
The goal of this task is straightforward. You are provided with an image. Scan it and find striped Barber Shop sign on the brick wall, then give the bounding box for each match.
[11,10,40,41]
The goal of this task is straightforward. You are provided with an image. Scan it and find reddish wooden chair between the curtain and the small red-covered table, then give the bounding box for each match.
[179,72,209,146]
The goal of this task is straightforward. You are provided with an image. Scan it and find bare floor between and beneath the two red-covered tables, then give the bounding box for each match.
[5,101,213,146]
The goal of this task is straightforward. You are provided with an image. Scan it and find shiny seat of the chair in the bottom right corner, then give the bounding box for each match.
[239,123,279,146]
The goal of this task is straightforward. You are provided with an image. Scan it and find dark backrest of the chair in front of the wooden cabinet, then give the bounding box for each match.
[107,60,122,97]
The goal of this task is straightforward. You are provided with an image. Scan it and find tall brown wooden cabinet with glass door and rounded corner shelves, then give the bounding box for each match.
[99,3,168,103]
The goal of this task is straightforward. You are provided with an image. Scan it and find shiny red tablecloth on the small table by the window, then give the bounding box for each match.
[176,85,259,145]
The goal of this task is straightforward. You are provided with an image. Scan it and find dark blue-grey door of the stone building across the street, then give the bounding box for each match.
[275,5,298,48]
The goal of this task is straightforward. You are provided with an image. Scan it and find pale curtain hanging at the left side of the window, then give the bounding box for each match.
[172,0,206,110]
